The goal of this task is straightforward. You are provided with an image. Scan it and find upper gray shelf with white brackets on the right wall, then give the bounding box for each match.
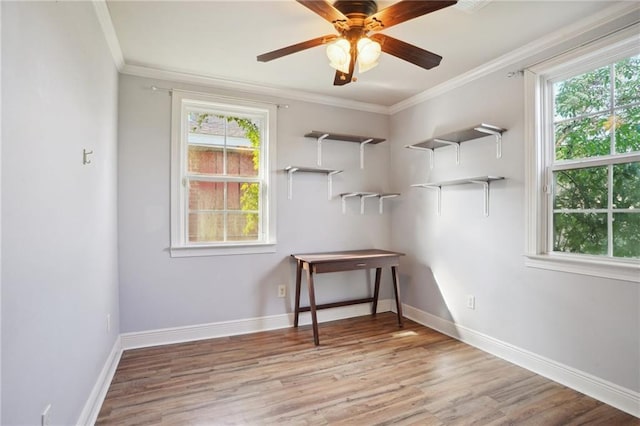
[405,123,507,168]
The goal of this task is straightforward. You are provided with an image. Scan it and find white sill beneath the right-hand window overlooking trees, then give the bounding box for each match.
[525,253,640,283]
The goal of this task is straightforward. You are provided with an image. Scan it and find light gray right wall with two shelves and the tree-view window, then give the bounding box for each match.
[390,65,640,391]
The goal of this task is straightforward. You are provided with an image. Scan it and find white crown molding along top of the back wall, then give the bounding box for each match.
[120,64,389,115]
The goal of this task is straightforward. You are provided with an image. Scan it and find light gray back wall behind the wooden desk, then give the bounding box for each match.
[118,75,393,332]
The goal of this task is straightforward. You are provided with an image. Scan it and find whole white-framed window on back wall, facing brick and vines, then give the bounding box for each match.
[171,90,275,256]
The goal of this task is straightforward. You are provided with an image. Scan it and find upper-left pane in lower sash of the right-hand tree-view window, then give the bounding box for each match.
[553,167,608,209]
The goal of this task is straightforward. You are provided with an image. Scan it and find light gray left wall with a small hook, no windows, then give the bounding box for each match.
[1,2,119,425]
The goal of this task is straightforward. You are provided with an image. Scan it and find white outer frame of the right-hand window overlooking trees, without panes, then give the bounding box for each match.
[524,25,640,282]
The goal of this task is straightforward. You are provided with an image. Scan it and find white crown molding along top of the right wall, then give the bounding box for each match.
[389,1,640,115]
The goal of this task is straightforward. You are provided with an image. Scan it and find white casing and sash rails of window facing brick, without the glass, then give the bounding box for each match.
[170,90,276,257]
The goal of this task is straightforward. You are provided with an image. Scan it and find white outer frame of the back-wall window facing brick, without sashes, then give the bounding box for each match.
[170,89,277,257]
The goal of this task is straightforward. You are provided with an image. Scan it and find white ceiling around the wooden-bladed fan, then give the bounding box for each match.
[107,0,632,107]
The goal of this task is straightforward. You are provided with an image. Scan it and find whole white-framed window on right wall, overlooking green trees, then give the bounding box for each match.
[525,25,640,281]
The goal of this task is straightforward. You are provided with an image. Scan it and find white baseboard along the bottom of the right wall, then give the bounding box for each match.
[402,305,640,417]
